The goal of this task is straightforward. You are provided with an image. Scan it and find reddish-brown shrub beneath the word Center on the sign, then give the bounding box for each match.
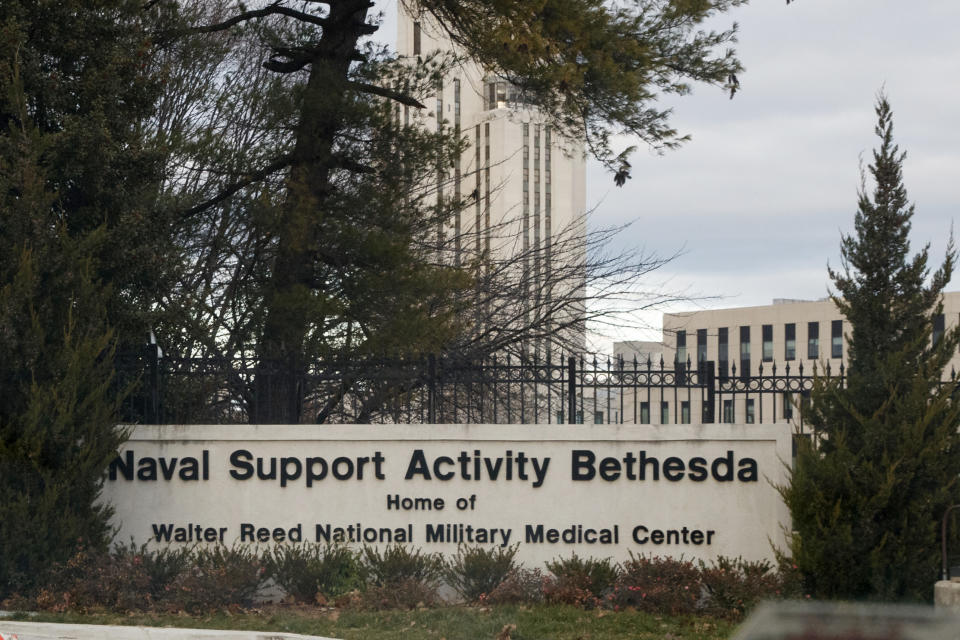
[606,553,700,615]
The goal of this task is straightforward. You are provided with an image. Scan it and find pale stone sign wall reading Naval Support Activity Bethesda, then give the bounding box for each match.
[104,425,790,562]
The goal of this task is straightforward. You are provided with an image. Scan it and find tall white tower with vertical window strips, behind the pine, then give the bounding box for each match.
[397,8,586,356]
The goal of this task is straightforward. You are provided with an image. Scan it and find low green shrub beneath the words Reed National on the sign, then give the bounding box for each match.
[263,543,364,602]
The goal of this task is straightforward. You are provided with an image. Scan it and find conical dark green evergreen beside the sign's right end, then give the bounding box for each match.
[781,95,960,600]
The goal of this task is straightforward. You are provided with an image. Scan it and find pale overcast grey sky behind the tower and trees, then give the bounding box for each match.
[372,0,960,350]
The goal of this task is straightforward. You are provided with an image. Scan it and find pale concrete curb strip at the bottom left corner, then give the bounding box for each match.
[0,619,335,640]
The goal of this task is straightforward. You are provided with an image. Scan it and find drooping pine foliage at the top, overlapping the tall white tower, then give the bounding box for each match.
[424,0,745,169]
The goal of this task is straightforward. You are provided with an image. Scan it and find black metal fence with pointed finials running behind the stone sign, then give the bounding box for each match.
[117,345,844,426]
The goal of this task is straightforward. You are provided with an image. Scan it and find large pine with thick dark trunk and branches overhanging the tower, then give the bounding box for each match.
[164,0,741,422]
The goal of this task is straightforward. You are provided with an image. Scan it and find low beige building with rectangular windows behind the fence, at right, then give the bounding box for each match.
[614,292,960,426]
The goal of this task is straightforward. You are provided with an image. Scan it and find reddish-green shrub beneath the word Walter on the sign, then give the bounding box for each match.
[163,545,268,613]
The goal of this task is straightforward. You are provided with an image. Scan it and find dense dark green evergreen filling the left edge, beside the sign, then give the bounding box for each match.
[0,0,166,595]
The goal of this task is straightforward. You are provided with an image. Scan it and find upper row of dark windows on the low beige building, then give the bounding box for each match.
[676,320,844,372]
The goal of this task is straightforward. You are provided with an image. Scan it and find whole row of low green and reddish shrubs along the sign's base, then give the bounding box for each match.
[0,543,801,620]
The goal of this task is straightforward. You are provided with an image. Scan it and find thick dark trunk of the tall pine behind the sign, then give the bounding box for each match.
[250,1,371,424]
